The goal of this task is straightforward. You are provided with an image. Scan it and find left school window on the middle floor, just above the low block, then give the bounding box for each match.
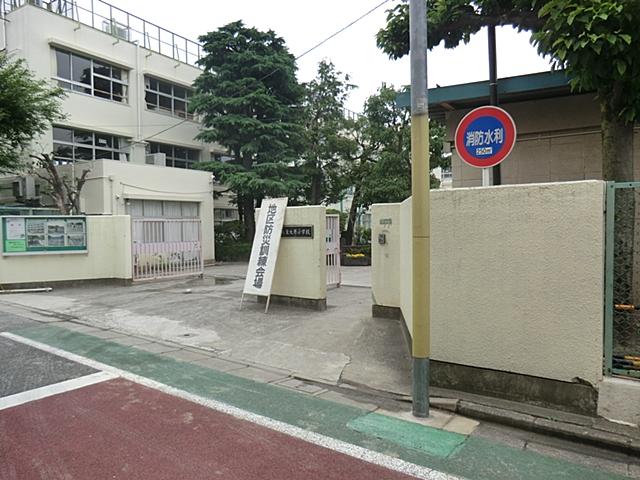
[53,127,127,165]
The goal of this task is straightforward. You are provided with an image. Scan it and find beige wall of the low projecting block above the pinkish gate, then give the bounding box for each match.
[76,160,215,261]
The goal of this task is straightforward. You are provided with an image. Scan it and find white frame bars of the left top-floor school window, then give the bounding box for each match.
[53,47,129,105]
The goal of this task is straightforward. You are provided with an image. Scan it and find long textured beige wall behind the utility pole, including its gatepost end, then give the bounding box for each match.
[372,181,604,384]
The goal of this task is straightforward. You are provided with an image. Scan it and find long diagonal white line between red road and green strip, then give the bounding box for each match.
[0,332,462,480]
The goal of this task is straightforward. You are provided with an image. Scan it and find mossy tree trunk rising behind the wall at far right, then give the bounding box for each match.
[599,83,634,182]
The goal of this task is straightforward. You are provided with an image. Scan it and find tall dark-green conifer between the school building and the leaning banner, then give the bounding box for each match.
[192,21,304,239]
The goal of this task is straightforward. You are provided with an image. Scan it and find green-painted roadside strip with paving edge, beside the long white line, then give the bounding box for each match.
[2,322,640,480]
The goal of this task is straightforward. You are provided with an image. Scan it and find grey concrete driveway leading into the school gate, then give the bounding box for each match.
[0,263,411,395]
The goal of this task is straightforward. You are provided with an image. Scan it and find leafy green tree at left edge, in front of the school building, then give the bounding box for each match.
[0,52,63,173]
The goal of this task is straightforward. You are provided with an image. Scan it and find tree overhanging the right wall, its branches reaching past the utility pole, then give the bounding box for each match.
[376,0,640,181]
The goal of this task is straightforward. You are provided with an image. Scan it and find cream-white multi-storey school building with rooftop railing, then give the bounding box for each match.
[0,0,230,261]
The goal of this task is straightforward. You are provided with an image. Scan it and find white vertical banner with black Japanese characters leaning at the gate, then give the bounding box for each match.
[242,197,288,313]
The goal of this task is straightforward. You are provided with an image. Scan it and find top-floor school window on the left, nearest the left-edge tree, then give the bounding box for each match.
[54,48,129,103]
